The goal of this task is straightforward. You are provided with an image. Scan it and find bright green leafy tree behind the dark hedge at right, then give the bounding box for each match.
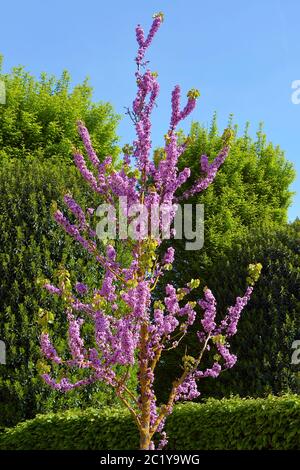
[170,115,295,283]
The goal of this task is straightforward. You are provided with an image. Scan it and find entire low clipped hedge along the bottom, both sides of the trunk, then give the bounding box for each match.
[0,395,300,450]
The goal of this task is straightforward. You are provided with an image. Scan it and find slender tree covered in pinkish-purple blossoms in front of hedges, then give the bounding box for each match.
[41,13,260,449]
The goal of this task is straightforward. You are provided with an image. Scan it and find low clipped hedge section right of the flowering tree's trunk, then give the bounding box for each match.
[167,396,300,450]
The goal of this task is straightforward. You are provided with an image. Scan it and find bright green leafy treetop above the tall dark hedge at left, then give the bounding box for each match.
[0,57,118,161]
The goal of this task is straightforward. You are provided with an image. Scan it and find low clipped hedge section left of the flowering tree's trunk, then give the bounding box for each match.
[0,408,139,450]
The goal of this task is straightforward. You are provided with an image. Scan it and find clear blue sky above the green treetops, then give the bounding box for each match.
[0,0,300,220]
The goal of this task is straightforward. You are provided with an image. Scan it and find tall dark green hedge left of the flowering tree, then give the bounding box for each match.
[0,160,123,425]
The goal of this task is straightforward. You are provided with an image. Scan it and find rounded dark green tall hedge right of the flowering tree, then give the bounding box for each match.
[157,221,300,399]
